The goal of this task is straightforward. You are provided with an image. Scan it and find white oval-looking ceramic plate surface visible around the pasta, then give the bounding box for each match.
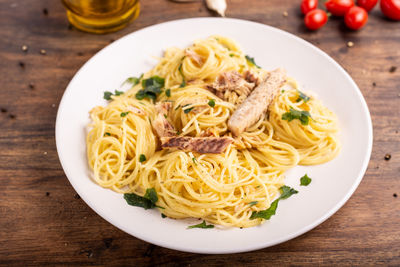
[56,18,372,254]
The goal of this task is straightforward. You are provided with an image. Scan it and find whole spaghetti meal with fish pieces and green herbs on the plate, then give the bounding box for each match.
[87,36,340,228]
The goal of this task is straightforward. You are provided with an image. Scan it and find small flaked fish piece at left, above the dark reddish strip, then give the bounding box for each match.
[152,102,176,137]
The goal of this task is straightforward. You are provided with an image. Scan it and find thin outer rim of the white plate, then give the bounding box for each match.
[55,17,373,254]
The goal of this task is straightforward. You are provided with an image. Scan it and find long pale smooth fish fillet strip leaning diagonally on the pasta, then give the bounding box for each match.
[228,68,286,136]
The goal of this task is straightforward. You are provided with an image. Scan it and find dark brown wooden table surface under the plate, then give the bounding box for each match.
[0,0,400,266]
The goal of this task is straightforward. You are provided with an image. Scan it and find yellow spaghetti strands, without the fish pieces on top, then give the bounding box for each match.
[86,36,340,227]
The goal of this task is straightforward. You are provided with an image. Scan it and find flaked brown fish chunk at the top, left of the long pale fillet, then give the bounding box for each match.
[207,71,256,104]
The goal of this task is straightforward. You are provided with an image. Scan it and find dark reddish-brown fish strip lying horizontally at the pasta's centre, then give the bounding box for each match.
[161,136,233,154]
